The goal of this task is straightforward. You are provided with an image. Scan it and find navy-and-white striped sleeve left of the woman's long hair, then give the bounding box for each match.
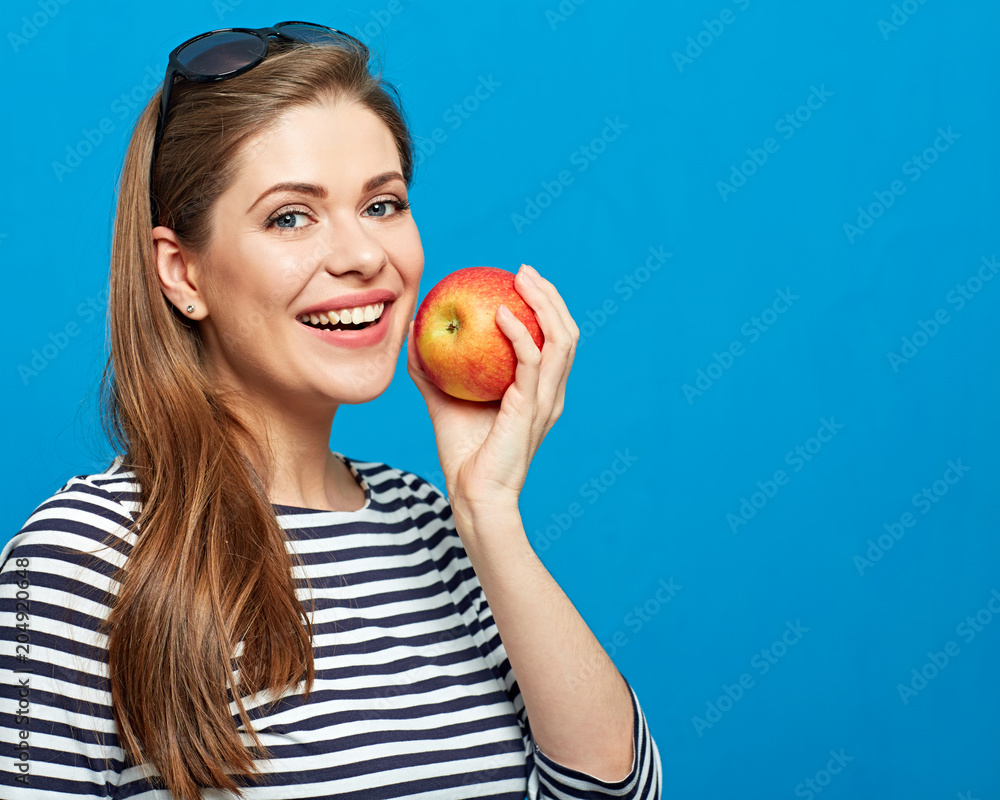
[0,478,128,800]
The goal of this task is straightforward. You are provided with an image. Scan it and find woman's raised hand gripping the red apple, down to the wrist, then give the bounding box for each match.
[407,265,580,512]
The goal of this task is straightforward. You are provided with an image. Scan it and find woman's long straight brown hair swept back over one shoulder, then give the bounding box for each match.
[94,42,413,800]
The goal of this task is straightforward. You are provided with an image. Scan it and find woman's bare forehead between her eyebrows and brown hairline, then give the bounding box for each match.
[233,101,401,191]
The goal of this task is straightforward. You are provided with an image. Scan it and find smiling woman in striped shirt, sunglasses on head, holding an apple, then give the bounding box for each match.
[0,18,661,800]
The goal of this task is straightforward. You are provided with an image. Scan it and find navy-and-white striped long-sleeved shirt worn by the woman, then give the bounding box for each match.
[0,453,662,800]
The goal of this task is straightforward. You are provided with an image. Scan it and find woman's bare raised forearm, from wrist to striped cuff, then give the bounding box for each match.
[455,500,634,781]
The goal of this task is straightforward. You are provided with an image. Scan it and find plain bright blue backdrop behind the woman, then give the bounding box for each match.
[0,0,1000,800]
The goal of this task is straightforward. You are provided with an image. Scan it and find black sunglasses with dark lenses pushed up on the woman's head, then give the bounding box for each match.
[149,21,368,223]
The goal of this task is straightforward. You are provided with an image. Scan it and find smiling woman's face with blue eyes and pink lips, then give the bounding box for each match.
[187,103,424,413]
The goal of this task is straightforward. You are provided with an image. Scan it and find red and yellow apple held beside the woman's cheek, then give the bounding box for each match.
[413,267,545,402]
